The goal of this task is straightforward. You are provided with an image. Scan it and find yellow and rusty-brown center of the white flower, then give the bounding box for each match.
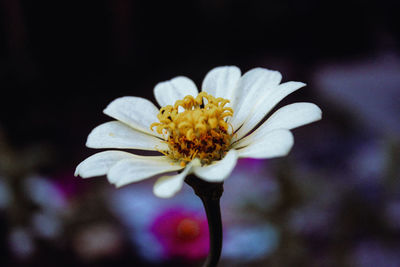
[150,92,233,166]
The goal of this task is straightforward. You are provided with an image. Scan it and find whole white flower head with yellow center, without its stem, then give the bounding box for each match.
[75,66,322,197]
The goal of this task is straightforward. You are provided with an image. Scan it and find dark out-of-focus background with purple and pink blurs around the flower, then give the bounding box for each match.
[0,0,400,267]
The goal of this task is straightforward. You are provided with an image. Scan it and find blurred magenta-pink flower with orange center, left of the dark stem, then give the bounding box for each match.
[150,208,209,260]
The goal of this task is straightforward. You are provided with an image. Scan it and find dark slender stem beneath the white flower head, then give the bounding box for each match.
[185,175,224,267]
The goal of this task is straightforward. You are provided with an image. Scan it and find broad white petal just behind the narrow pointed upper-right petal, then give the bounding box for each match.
[230,68,282,129]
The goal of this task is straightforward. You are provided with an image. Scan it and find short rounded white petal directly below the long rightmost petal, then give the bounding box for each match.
[237,129,294,159]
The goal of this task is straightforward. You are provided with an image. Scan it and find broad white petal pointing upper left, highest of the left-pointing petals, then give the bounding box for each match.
[103,96,162,136]
